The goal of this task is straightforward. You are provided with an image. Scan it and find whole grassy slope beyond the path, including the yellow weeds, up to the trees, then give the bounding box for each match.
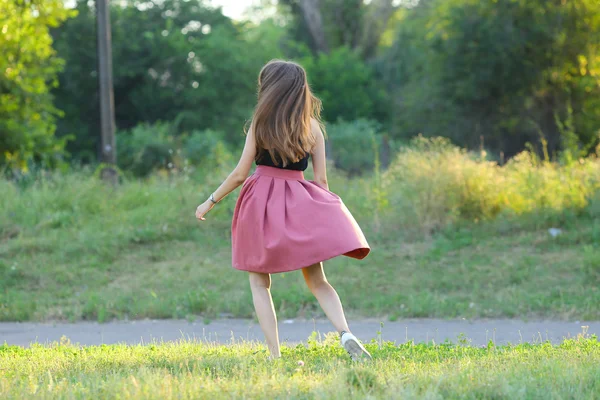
[0,141,600,321]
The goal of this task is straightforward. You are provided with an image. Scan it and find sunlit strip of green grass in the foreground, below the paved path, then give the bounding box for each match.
[0,335,600,400]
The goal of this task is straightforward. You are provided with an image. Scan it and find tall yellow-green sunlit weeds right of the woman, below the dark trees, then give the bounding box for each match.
[383,137,600,232]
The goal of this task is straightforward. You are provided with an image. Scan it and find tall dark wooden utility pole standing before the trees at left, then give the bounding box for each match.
[96,0,118,184]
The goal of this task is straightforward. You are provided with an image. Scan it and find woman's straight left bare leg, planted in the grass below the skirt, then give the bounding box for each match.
[250,272,281,358]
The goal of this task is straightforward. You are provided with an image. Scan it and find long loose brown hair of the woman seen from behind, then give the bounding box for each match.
[251,60,323,167]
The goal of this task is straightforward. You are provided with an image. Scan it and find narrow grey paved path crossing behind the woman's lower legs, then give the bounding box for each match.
[0,319,600,346]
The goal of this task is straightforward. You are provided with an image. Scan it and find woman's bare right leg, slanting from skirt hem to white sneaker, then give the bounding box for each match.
[302,263,350,333]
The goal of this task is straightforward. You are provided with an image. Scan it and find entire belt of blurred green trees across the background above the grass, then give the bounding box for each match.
[0,0,600,168]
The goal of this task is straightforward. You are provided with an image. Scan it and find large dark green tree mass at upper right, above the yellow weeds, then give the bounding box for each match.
[382,0,600,155]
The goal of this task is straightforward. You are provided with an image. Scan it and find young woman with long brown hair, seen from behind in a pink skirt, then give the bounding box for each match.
[196,60,371,359]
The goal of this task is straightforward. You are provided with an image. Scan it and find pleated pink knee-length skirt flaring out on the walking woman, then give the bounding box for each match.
[231,166,370,273]
